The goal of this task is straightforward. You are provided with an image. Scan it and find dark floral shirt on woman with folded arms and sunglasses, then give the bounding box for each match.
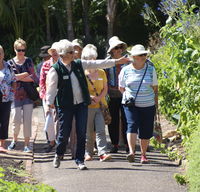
[8,57,38,107]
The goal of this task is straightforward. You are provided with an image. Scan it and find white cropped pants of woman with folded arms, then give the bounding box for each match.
[11,104,33,137]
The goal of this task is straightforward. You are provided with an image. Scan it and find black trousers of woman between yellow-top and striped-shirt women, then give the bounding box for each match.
[108,97,127,145]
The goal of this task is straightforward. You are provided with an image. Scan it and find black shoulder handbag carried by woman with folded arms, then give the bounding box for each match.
[12,59,39,101]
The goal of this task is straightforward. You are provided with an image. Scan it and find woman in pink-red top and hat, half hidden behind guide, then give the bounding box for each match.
[39,42,59,153]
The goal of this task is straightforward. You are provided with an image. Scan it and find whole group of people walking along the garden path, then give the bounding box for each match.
[0,36,158,170]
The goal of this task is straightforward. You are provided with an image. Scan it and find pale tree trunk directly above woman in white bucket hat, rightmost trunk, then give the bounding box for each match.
[106,0,117,39]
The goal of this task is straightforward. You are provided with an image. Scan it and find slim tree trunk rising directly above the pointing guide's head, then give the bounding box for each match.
[66,0,74,41]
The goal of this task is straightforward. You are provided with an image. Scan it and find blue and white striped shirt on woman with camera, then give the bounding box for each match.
[119,63,158,107]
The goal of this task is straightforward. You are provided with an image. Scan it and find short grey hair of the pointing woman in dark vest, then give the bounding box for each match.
[56,39,74,56]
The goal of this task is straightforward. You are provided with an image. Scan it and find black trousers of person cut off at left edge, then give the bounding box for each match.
[0,101,11,140]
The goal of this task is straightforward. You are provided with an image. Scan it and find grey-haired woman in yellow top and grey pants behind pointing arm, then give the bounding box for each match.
[82,44,111,161]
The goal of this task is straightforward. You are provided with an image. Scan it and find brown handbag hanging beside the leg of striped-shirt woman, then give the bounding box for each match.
[153,109,162,143]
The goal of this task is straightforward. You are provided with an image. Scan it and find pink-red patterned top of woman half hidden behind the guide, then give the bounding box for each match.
[39,57,54,99]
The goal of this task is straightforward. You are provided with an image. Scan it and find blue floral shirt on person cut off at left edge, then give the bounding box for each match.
[0,61,16,102]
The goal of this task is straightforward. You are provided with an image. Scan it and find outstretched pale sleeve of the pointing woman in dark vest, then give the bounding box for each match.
[81,59,115,70]
